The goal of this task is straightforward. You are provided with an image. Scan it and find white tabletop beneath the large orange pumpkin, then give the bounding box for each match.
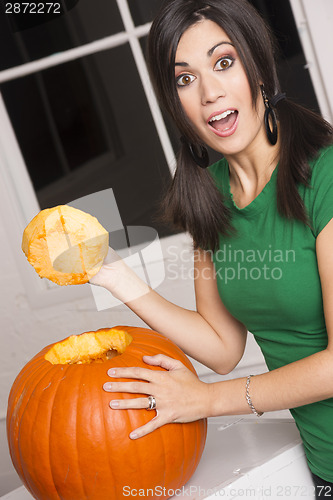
[1,415,314,500]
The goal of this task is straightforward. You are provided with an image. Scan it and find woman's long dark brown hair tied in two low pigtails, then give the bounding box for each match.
[148,0,333,250]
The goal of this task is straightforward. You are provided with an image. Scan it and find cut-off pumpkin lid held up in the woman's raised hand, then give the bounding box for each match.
[22,205,109,285]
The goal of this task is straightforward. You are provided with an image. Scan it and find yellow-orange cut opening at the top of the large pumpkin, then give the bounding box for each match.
[44,328,133,365]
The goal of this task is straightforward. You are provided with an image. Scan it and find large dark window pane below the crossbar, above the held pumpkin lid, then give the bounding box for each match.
[0,45,174,234]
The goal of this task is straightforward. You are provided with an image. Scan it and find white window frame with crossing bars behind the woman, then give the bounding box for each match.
[0,0,176,308]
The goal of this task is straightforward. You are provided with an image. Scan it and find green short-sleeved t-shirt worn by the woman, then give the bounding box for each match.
[210,146,333,482]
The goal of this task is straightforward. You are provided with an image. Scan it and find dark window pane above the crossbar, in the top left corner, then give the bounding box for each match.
[0,0,124,70]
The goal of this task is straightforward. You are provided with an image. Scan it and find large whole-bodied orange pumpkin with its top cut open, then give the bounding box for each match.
[7,326,207,500]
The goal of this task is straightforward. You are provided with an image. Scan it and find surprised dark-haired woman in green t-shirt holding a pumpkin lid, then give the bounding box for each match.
[93,0,333,496]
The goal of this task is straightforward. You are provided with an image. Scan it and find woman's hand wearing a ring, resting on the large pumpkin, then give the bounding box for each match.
[103,354,211,439]
